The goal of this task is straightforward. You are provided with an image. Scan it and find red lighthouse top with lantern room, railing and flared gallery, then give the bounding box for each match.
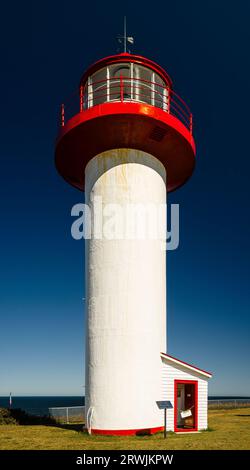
[56,52,195,192]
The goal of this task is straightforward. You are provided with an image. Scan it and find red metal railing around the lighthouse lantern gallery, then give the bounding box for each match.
[61,76,193,134]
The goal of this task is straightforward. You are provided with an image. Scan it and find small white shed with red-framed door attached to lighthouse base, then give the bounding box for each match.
[161,353,212,432]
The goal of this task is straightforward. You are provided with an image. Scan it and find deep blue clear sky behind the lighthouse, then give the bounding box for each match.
[0,0,250,395]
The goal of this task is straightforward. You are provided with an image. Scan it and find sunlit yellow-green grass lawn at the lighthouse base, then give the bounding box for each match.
[0,408,250,450]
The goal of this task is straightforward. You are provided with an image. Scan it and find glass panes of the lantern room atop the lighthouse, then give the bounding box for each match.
[84,62,169,111]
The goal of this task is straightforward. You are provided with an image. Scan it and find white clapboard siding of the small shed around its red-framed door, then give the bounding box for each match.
[162,357,208,431]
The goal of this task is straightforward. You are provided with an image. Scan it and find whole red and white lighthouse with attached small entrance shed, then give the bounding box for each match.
[55,43,211,435]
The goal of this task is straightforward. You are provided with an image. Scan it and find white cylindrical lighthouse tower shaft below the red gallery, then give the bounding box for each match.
[85,149,166,431]
